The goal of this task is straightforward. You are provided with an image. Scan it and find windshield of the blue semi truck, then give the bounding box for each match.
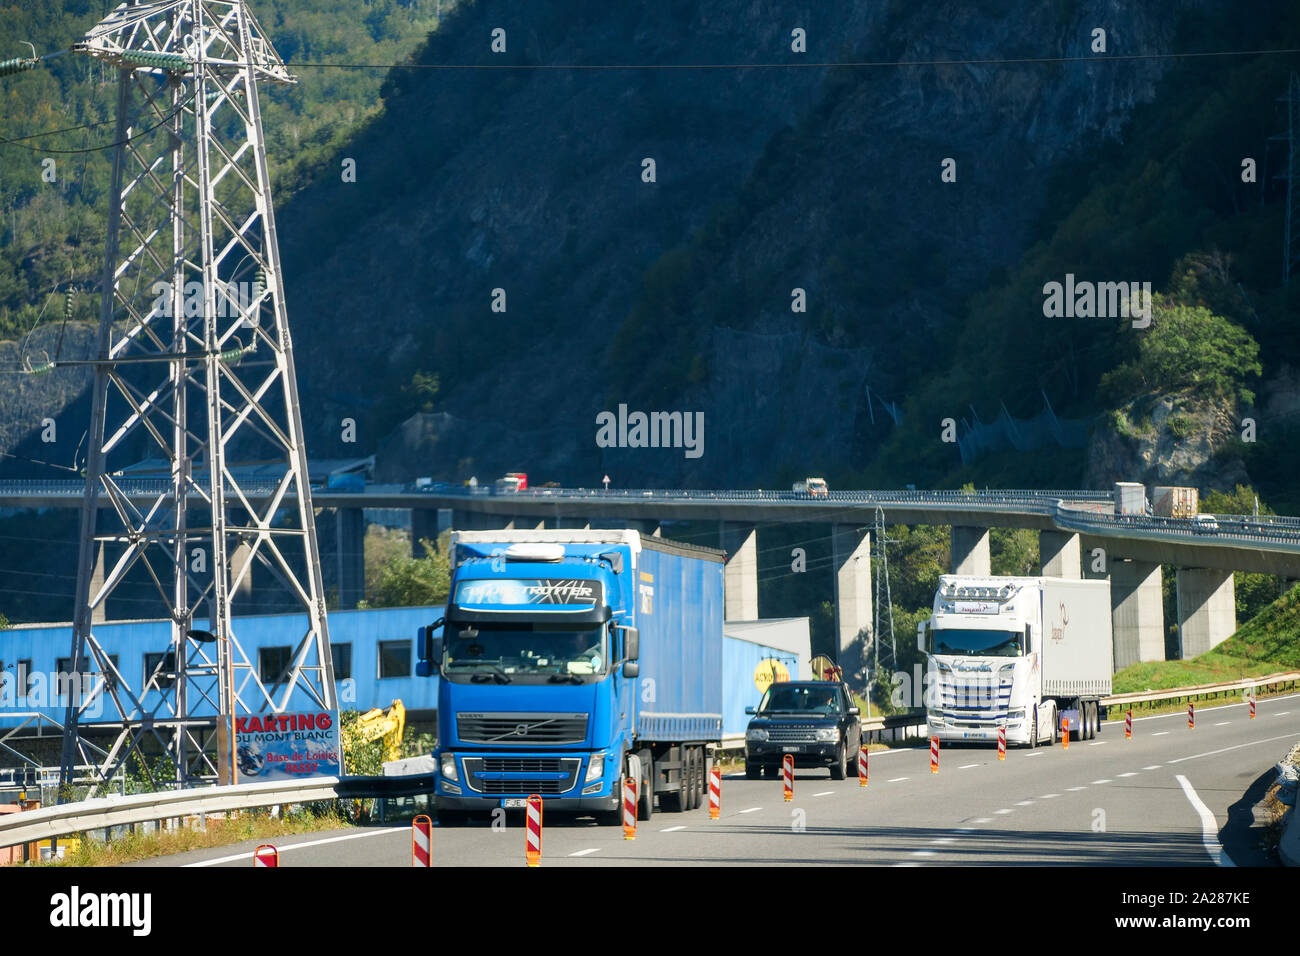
[443,623,608,683]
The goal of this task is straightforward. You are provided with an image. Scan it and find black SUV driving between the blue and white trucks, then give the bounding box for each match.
[745,680,862,780]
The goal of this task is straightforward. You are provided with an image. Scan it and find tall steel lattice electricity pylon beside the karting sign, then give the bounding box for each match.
[57,0,335,799]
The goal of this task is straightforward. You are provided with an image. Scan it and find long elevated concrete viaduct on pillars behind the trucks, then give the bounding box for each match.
[0,481,1300,667]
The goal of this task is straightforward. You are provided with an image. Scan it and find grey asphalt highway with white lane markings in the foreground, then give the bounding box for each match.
[126,696,1300,866]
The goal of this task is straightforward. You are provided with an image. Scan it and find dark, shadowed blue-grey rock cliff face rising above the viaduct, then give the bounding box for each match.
[280,0,1196,485]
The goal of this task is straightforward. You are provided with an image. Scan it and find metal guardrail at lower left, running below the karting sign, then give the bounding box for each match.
[0,777,433,847]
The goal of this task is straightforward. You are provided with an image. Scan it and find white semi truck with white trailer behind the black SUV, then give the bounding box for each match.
[917,575,1114,747]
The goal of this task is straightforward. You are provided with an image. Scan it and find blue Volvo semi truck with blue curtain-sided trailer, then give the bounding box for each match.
[417,529,724,825]
